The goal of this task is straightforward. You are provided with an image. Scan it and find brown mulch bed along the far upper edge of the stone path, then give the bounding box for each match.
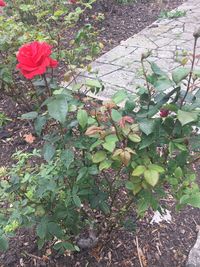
[93,0,184,52]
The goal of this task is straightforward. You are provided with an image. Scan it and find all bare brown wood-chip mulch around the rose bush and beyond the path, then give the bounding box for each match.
[0,0,200,267]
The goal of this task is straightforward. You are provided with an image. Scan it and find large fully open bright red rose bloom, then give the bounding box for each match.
[16,41,58,79]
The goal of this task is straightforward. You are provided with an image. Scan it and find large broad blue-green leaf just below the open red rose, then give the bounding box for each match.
[47,95,68,123]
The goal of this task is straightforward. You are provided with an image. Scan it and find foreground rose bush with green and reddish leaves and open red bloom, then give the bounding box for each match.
[0,0,200,266]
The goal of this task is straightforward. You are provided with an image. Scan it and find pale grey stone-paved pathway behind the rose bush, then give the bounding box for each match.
[63,0,200,99]
